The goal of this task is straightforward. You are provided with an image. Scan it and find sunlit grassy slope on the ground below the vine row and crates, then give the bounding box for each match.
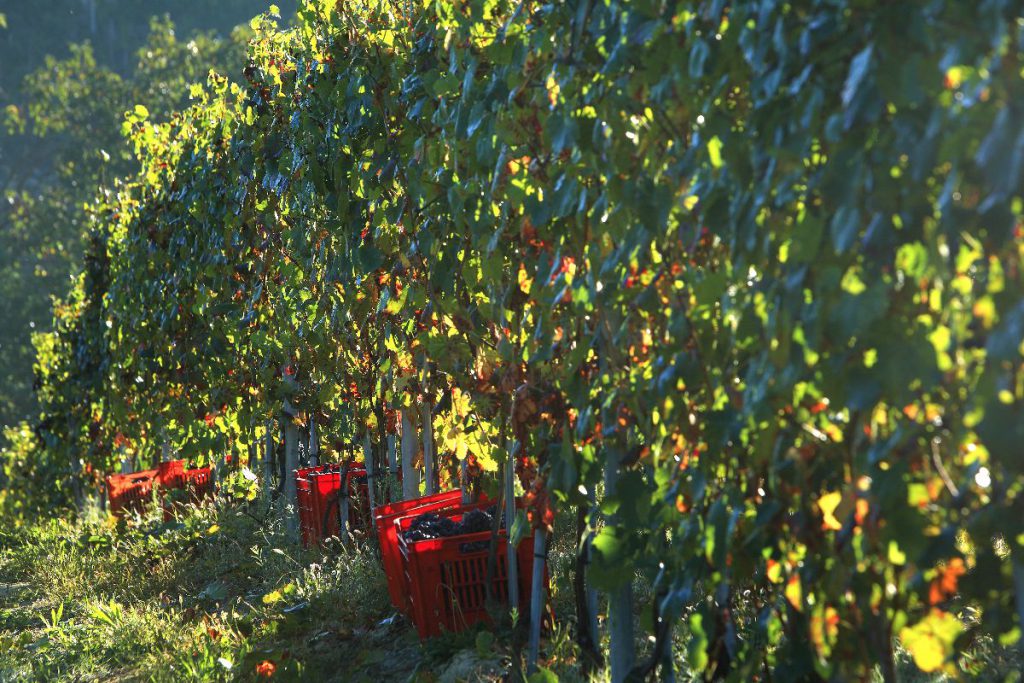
[0,499,1021,683]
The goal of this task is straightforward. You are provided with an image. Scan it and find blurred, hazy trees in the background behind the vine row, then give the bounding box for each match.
[0,0,295,447]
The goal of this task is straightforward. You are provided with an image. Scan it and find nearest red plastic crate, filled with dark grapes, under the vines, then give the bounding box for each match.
[395,504,547,639]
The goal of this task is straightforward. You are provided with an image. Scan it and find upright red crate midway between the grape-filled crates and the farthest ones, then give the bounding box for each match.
[295,464,370,547]
